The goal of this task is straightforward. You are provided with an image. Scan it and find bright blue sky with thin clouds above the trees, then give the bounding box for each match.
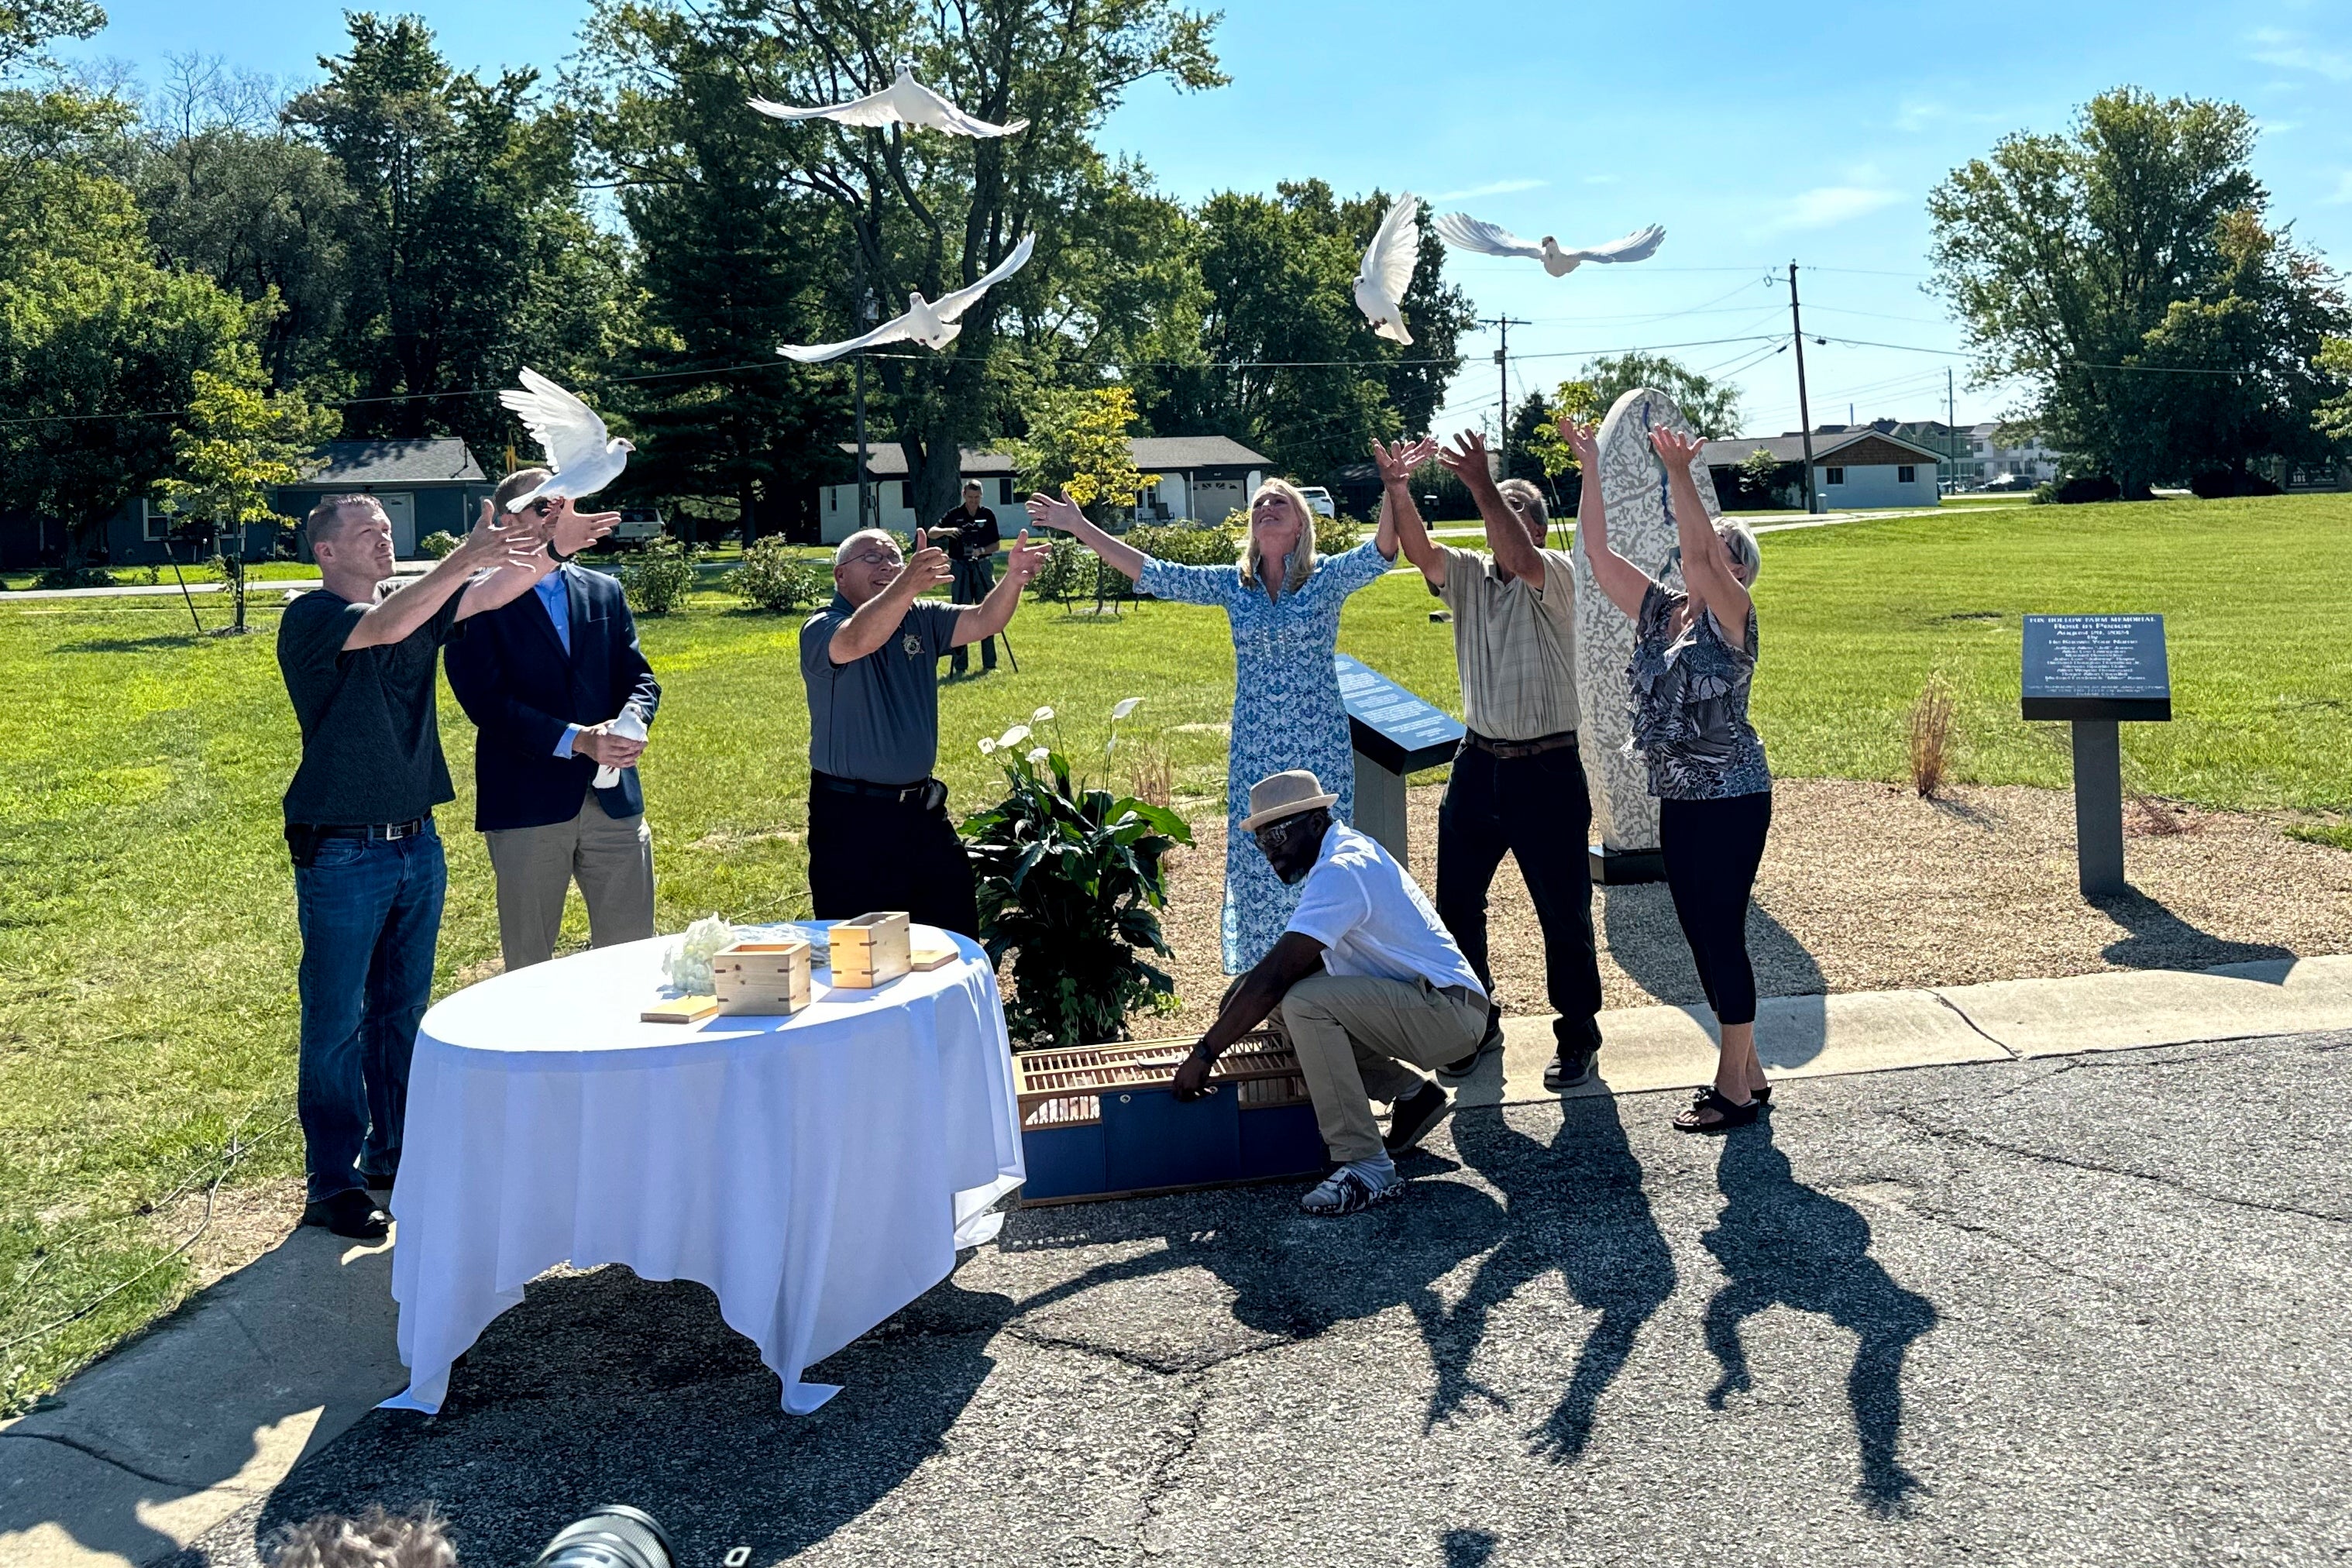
[60,0,2352,432]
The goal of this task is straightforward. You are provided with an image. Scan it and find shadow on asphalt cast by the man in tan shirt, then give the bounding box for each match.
[1423,1098,1675,1462]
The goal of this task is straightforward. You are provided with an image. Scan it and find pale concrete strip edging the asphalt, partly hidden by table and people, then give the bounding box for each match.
[13,957,2352,1568]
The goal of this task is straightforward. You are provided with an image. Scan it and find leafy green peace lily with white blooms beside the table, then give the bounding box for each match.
[965,698,1192,1048]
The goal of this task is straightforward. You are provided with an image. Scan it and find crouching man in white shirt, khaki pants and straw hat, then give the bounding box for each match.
[1176,769,1487,1216]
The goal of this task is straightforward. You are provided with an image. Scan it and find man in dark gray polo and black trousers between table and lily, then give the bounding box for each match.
[799,529,1047,938]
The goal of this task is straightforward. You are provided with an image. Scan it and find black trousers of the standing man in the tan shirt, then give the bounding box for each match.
[1437,745,1602,1048]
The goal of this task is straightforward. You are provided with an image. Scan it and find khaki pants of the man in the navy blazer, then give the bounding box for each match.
[482,793,654,971]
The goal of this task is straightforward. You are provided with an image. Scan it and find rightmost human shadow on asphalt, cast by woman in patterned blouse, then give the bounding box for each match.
[1700,1121,1938,1514]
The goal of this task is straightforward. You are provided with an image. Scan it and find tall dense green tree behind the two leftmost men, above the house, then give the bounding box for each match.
[284,12,626,449]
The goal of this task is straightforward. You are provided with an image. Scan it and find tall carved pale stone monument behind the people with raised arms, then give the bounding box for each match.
[1573,386,1721,882]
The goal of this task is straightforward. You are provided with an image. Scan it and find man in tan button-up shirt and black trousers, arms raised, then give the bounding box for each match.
[1374,432,1602,1088]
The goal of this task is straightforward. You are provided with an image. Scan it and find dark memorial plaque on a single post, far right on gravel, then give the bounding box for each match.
[2020,616,2173,896]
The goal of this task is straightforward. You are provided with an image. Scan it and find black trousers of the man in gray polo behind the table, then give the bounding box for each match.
[809,782,981,940]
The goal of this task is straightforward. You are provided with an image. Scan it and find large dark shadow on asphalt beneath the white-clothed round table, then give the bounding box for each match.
[254,1267,1011,1566]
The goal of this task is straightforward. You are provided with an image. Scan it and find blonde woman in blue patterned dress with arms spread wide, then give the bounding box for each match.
[1028,469,1425,975]
